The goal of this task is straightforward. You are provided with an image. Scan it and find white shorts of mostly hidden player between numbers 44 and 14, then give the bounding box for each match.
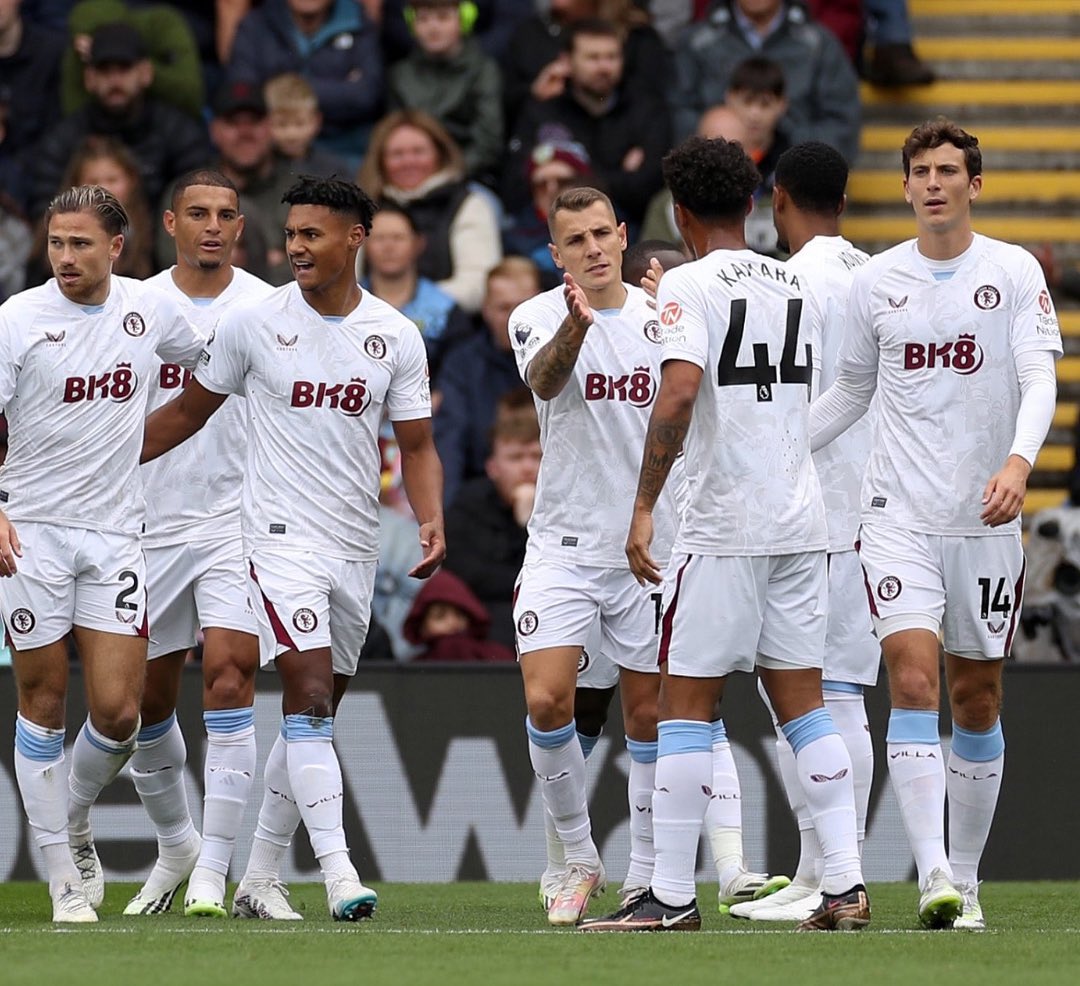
[825,551,881,685]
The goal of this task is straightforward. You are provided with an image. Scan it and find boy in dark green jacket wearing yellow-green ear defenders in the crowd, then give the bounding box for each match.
[387,0,503,185]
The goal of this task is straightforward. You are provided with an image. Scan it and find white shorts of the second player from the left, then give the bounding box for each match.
[144,531,258,660]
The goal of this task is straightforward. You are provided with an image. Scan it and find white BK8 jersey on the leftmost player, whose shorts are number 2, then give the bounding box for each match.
[0,276,205,535]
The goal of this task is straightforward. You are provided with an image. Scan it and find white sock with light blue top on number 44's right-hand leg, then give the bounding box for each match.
[782,708,863,894]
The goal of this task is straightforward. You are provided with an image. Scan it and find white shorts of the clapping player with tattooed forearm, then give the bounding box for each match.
[514,560,660,673]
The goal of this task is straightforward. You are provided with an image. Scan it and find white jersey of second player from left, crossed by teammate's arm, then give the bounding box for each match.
[143,267,273,548]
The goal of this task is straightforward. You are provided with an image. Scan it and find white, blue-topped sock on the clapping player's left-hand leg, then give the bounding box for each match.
[525,718,599,867]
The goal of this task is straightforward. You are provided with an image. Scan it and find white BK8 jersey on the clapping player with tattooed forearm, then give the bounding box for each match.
[510,284,678,568]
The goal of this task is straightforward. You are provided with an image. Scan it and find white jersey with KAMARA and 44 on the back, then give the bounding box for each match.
[657,249,827,555]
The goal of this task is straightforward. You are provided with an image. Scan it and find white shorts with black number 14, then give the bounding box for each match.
[856,524,1024,661]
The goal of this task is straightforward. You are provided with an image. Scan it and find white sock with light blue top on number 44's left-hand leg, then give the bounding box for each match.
[652,719,713,907]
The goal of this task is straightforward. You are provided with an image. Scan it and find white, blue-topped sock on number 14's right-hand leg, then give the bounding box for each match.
[946,720,1005,887]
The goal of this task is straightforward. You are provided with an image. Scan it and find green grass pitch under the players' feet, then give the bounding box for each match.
[0,883,1080,986]
